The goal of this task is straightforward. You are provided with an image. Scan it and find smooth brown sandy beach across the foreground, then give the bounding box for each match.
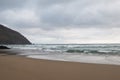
[0,56,120,80]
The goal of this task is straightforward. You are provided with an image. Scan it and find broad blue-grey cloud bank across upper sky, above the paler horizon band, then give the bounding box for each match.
[0,0,120,29]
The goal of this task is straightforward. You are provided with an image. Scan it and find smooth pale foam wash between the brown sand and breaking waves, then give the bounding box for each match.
[27,52,120,65]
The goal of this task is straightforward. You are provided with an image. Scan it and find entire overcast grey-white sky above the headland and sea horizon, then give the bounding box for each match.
[0,0,120,44]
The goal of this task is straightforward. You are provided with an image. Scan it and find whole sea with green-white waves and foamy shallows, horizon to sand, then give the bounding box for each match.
[2,44,120,65]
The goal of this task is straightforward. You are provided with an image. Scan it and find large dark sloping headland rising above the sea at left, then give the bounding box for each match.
[0,24,31,44]
